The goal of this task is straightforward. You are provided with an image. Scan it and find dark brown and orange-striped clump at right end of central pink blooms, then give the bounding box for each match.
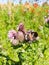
[25,31,38,42]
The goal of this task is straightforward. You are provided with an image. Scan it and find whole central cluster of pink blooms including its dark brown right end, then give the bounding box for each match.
[8,23,38,46]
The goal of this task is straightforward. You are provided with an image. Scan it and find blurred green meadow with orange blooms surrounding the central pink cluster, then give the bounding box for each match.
[0,3,49,65]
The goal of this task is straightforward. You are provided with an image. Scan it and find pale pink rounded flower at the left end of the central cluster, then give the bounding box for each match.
[8,30,18,45]
